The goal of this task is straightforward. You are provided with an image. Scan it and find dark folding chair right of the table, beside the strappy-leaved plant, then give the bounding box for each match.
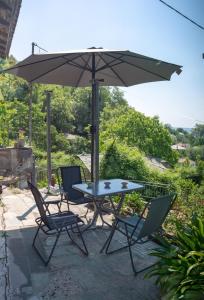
[100,194,176,275]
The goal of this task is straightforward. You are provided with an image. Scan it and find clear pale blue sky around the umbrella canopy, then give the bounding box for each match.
[10,0,204,128]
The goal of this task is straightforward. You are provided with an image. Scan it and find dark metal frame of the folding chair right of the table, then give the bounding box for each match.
[100,194,176,275]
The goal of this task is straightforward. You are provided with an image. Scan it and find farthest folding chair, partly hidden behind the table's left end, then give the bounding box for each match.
[59,166,93,218]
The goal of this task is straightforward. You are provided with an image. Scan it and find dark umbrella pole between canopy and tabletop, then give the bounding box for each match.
[91,80,99,182]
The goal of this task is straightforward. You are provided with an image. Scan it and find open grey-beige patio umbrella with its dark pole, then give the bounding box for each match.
[2,47,181,182]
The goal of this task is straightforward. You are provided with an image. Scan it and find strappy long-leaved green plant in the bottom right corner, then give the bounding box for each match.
[147,216,204,300]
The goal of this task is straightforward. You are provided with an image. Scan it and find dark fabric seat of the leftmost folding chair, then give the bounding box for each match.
[46,211,84,230]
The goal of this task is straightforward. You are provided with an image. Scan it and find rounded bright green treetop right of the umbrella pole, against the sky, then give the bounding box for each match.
[101,108,177,164]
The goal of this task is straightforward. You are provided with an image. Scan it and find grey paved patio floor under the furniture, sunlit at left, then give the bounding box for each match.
[0,189,160,300]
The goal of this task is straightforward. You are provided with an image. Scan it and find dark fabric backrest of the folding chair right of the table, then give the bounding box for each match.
[138,194,176,239]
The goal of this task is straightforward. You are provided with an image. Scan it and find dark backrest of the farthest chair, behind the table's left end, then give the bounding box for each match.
[60,166,83,202]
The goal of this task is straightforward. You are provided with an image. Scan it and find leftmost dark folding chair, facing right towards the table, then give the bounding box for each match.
[28,182,88,265]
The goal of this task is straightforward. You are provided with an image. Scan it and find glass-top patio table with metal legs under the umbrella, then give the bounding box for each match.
[72,179,144,227]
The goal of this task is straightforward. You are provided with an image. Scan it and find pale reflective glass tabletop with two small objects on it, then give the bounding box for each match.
[72,179,144,197]
